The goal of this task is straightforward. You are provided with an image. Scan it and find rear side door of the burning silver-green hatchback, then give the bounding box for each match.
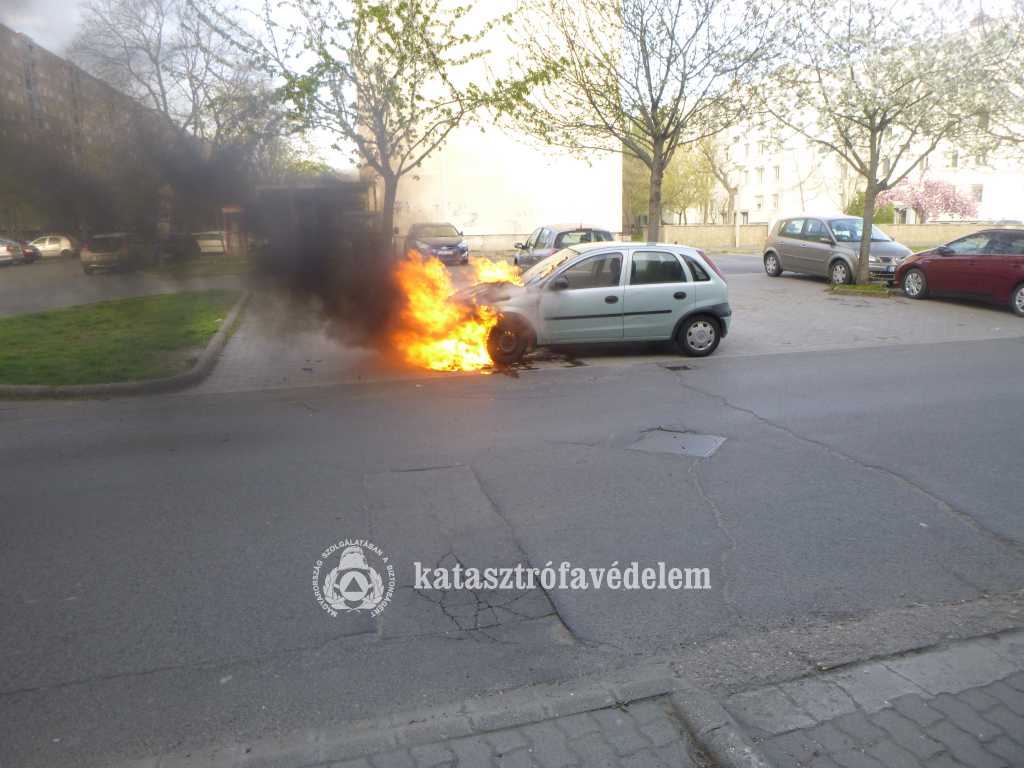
[623,250,697,339]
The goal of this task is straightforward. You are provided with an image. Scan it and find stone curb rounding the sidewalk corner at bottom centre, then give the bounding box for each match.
[110,665,771,768]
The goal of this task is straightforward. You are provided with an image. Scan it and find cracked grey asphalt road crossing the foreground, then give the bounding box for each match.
[0,296,1024,766]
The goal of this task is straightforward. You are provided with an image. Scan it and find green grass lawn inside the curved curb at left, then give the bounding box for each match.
[0,291,242,385]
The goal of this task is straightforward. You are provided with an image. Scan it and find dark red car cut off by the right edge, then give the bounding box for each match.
[896,229,1024,317]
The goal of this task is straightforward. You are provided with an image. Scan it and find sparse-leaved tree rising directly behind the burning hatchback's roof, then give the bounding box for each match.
[510,0,776,239]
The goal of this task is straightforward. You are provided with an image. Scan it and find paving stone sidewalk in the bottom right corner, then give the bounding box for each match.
[724,632,1024,768]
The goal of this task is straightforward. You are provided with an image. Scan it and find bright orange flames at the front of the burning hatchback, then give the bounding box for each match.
[391,253,519,371]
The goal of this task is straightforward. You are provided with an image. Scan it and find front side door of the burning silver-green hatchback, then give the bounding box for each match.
[539,252,624,343]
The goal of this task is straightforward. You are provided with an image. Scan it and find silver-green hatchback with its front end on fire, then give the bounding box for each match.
[450,243,732,365]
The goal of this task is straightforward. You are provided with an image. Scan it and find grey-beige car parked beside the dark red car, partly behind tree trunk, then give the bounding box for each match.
[763,216,911,286]
